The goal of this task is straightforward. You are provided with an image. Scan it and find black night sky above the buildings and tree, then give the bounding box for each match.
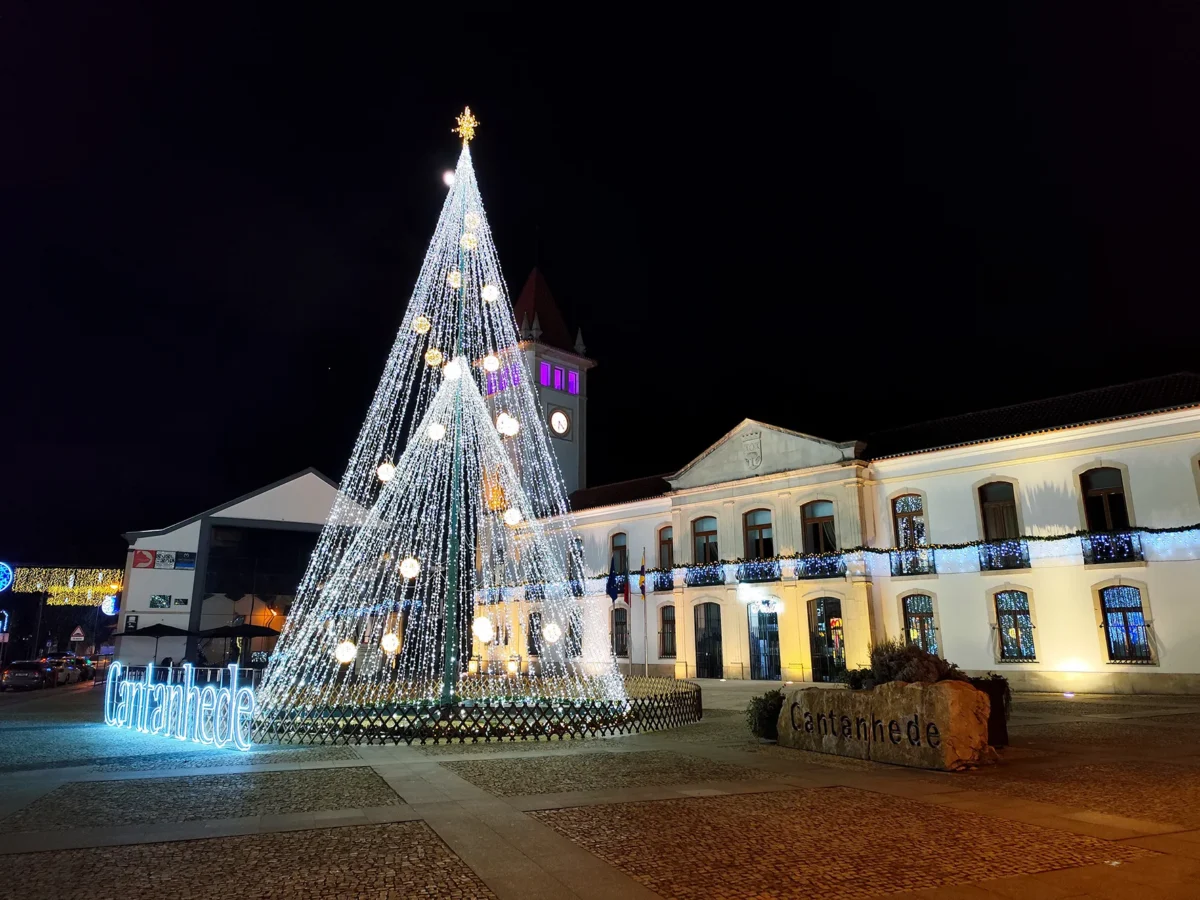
[0,2,1200,565]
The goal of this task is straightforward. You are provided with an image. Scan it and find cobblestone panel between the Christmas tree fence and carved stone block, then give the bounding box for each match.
[442,750,772,797]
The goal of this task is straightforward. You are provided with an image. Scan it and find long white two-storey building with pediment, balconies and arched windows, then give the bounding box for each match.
[572,376,1200,692]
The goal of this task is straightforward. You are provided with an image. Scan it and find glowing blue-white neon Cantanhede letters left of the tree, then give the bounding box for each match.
[104,662,254,750]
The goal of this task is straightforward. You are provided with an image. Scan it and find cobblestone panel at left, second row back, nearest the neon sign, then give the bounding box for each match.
[0,767,401,832]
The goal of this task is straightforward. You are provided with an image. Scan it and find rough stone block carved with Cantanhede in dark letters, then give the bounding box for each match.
[779,682,995,770]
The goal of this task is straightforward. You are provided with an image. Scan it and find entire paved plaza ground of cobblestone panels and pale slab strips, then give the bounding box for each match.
[0,682,1200,900]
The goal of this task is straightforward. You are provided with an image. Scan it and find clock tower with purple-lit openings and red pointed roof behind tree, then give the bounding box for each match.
[512,269,595,494]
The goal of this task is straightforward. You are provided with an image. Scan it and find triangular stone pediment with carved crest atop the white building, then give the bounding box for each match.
[667,419,857,491]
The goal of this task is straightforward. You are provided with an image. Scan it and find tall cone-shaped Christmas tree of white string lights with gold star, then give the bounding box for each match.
[258,108,625,739]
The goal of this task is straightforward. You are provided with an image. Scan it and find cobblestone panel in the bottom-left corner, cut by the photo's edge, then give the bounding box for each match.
[0,822,496,900]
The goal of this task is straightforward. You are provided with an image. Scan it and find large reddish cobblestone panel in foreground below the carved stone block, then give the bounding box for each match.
[533,787,1151,900]
